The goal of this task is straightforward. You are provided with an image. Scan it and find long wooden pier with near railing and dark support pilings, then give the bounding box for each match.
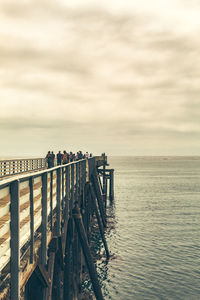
[0,154,114,300]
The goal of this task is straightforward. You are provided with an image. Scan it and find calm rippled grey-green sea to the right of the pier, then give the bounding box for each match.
[98,157,200,300]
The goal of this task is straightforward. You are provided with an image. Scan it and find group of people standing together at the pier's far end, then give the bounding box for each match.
[46,150,92,169]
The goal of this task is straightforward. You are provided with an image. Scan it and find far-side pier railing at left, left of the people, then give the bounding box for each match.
[0,158,46,178]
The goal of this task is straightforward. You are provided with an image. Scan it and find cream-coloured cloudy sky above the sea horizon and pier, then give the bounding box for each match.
[0,0,200,157]
